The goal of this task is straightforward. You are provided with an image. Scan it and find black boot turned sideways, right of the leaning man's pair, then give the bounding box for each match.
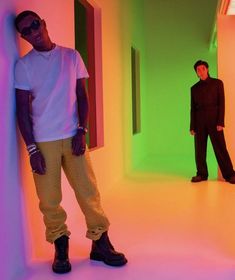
[90,231,127,266]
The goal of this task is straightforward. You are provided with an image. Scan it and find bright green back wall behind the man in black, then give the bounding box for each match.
[129,0,217,176]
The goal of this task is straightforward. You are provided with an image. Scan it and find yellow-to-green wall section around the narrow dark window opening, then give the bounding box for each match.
[120,0,148,174]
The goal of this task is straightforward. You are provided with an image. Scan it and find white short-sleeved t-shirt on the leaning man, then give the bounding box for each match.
[15,46,89,142]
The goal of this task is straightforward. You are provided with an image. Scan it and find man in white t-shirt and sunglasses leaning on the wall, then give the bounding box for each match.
[15,11,127,273]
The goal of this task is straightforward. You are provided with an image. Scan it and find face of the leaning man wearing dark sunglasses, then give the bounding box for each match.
[18,15,49,47]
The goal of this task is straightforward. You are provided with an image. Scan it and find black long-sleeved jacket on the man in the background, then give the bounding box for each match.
[190,77,225,131]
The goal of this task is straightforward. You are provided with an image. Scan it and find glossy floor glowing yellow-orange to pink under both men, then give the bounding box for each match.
[20,173,235,280]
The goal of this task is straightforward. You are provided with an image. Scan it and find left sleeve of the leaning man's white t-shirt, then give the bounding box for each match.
[15,60,31,90]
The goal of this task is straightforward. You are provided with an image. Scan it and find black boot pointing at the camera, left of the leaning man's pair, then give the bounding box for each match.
[52,235,71,273]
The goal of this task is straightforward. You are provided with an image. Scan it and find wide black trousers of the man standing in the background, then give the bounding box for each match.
[195,126,235,180]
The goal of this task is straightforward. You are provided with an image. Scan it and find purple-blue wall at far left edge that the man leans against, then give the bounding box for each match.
[0,8,26,280]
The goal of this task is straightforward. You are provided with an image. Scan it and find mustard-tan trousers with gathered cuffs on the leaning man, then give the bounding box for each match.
[33,138,109,243]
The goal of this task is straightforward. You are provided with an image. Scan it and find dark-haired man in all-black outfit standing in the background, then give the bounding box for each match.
[190,60,235,184]
